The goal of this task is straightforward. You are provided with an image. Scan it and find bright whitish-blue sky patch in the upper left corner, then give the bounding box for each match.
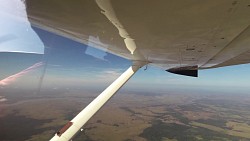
[0,0,44,54]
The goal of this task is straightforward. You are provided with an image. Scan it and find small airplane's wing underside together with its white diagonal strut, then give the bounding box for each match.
[0,0,250,141]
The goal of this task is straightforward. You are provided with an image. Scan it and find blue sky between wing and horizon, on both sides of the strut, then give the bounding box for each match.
[0,28,250,93]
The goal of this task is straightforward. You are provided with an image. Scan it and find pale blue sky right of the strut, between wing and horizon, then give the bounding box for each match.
[129,64,250,93]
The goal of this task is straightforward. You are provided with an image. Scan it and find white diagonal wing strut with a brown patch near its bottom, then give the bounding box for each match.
[50,62,145,141]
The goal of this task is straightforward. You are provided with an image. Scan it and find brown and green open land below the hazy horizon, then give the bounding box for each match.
[0,90,250,141]
